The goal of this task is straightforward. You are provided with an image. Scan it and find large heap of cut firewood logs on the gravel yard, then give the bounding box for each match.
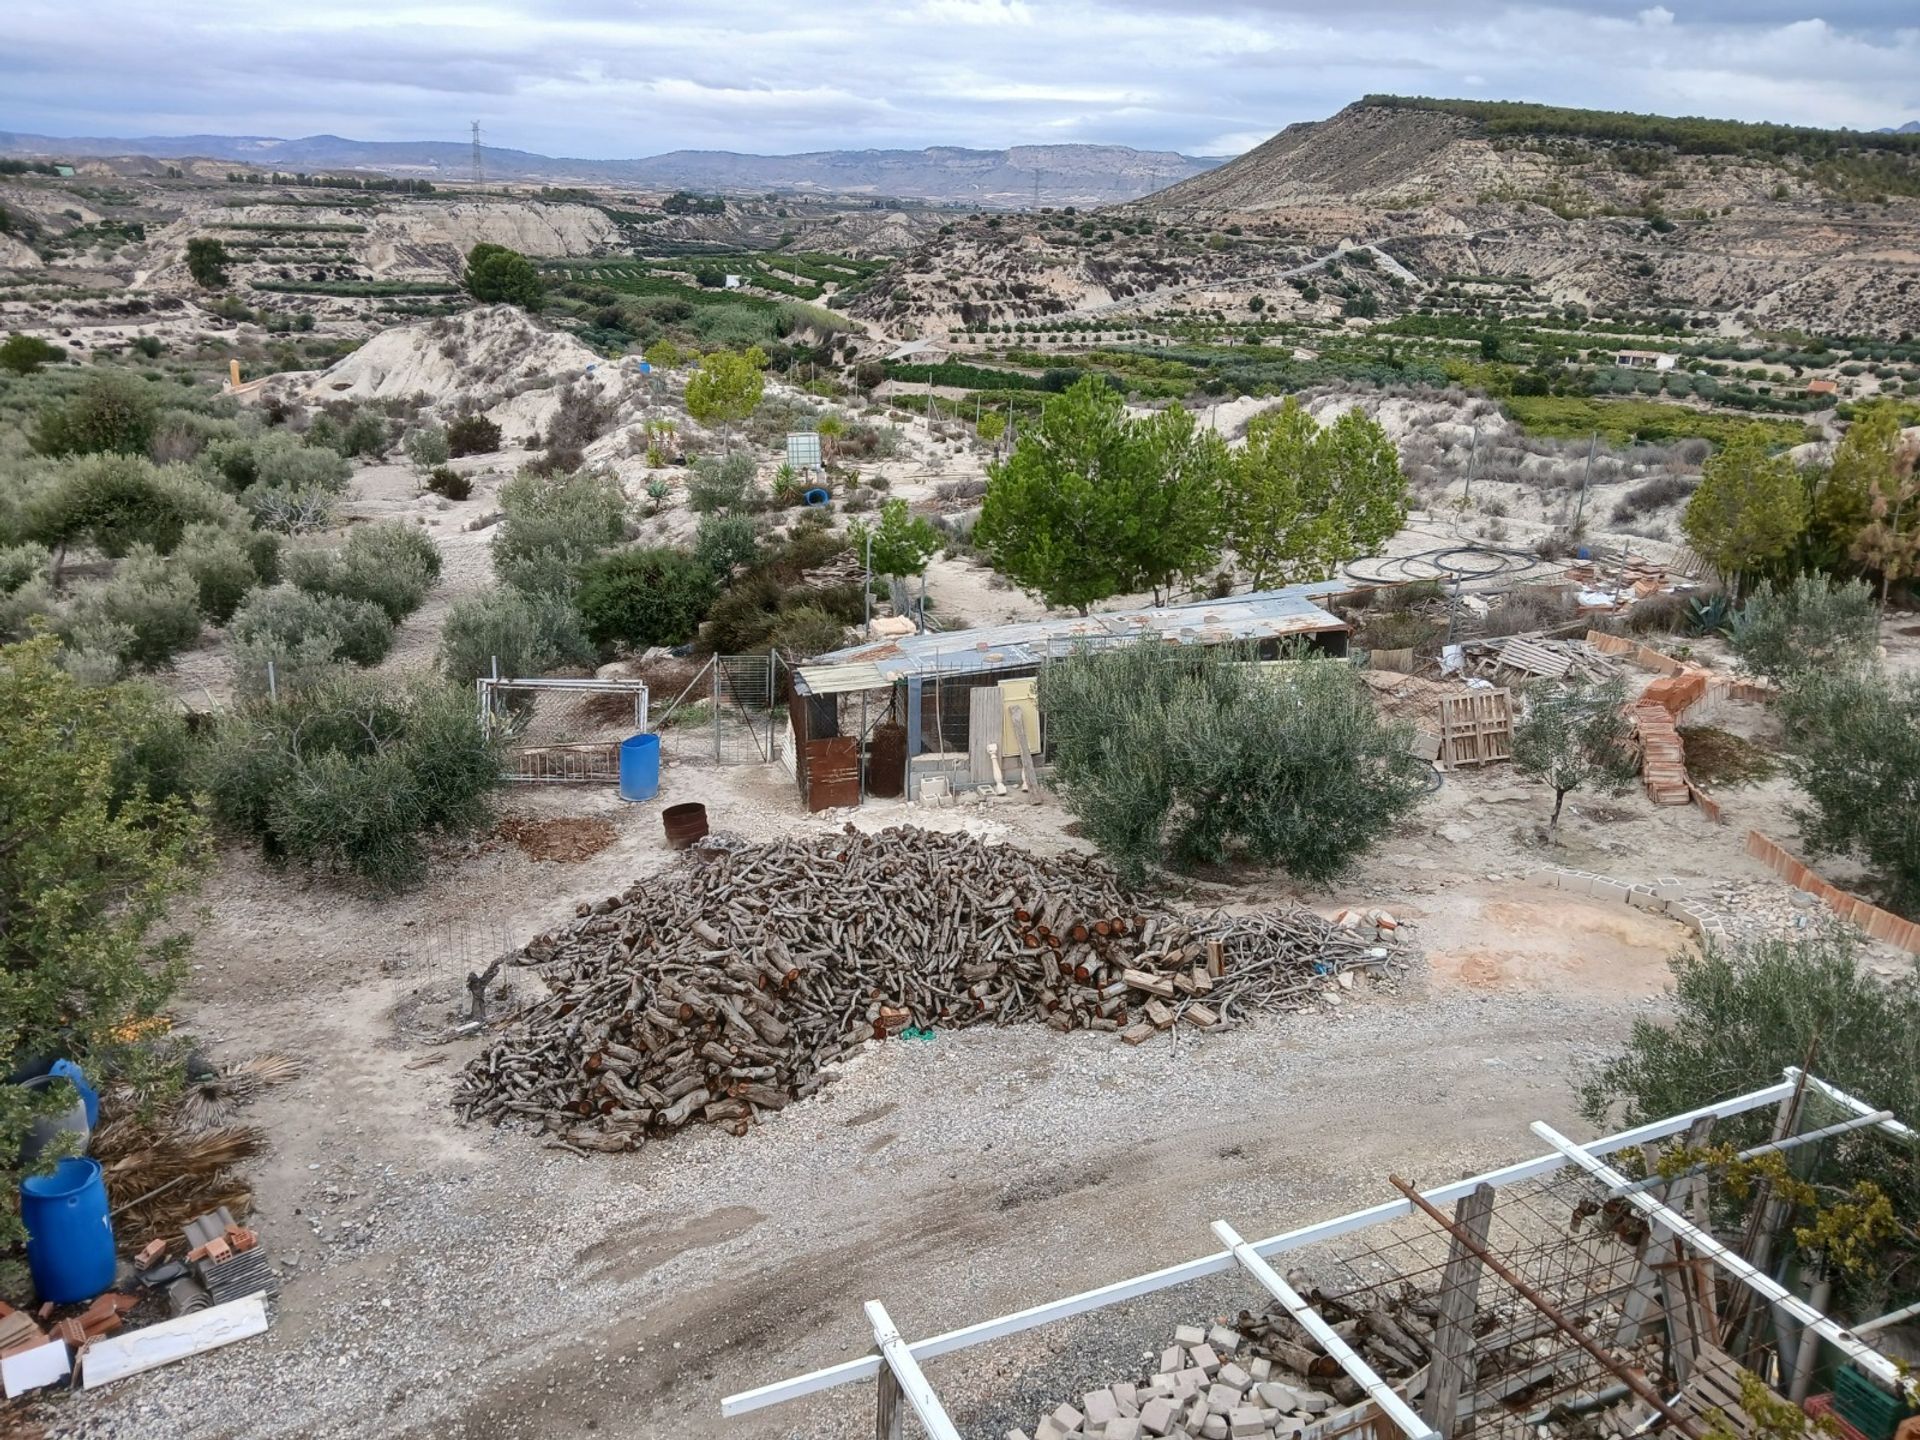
[457,826,1398,1150]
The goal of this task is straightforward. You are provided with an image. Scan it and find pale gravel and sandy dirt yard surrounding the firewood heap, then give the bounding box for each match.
[42,664,1895,1440]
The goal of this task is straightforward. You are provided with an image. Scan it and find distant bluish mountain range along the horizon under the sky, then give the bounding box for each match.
[0,131,1225,207]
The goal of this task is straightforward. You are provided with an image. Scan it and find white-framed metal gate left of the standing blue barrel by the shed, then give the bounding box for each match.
[474,678,647,785]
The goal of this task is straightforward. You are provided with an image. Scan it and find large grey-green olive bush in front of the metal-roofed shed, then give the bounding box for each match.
[1039,639,1427,881]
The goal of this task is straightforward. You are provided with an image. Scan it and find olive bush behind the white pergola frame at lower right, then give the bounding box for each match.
[1580,927,1920,1313]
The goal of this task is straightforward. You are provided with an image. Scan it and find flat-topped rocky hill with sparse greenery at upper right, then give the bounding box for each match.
[872,96,1920,338]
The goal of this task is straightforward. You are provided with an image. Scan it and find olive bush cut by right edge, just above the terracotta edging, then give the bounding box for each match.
[1782,666,1920,916]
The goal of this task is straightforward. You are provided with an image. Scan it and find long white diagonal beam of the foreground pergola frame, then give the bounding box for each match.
[720,1069,1920,1434]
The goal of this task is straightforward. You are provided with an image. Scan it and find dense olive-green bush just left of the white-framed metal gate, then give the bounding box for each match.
[202,674,499,891]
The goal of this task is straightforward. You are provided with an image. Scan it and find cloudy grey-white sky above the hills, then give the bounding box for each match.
[11,0,1920,157]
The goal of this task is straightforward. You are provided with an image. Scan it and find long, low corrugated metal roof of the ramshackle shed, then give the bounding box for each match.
[797,580,1348,695]
